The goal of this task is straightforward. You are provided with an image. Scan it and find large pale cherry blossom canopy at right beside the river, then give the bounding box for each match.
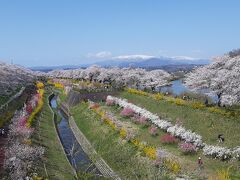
[185,54,240,105]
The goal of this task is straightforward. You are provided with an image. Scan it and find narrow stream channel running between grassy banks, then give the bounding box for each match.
[50,96,102,176]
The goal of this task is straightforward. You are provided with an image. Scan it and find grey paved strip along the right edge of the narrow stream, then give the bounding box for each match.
[69,116,120,180]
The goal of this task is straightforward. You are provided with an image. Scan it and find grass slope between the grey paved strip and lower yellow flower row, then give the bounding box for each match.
[71,103,173,179]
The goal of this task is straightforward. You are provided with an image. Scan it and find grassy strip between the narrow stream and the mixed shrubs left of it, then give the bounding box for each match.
[33,91,75,180]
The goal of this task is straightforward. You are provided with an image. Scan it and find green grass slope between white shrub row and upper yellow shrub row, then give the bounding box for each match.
[119,92,240,147]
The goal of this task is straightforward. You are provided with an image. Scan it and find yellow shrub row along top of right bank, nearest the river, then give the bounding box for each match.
[127,88,236,117]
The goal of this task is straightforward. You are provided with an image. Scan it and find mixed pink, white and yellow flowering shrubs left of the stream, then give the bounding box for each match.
[4,83,44,179]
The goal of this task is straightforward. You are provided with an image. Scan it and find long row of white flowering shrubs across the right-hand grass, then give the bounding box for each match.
[106,96,240,160]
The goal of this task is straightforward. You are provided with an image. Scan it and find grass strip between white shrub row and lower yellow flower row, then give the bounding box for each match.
[102,102,239,178]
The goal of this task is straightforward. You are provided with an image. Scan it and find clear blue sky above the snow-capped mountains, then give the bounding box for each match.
[0,0,240,66]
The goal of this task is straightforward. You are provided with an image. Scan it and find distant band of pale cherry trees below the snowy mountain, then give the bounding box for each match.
[45,65,172,88]
